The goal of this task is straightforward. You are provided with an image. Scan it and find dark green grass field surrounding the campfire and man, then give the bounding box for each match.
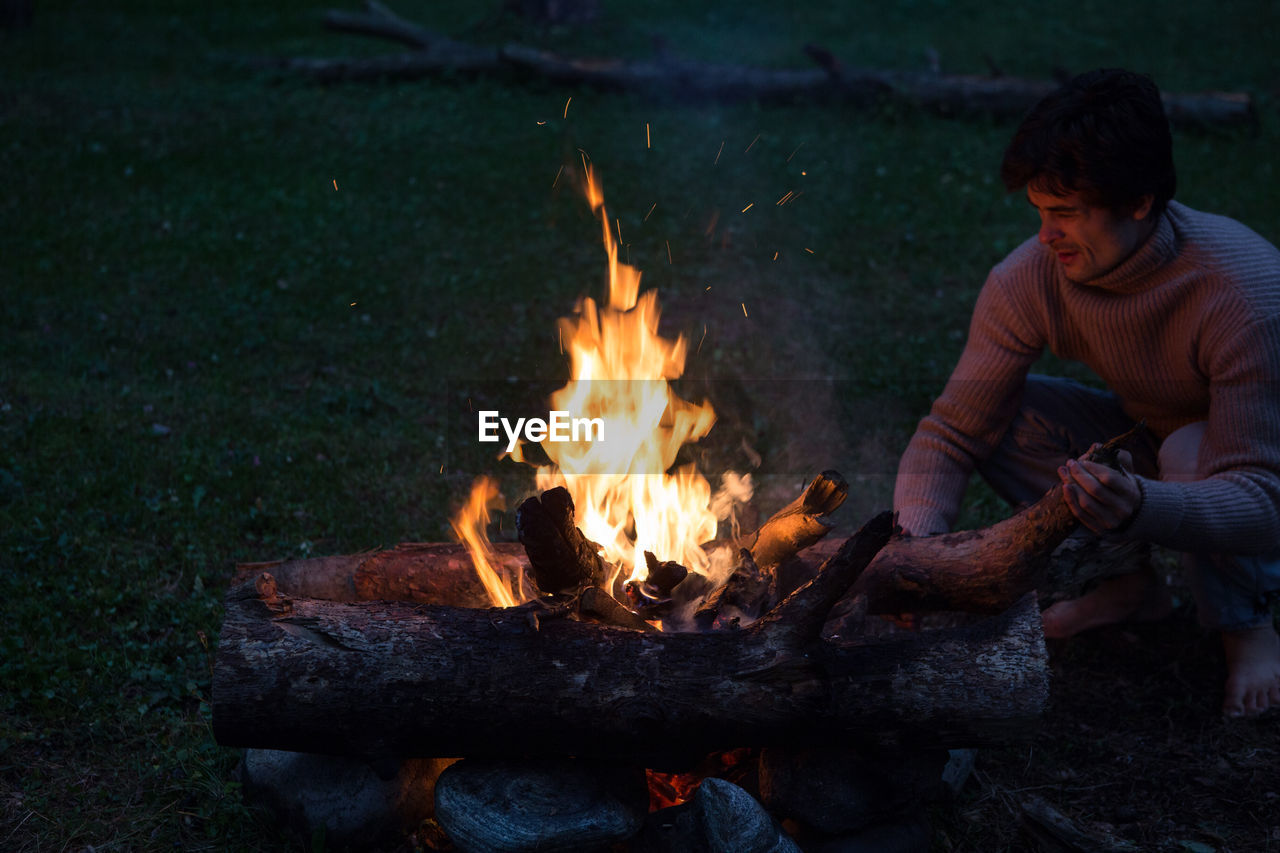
[0,0,1280,852]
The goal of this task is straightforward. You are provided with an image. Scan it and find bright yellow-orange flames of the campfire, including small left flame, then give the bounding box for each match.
[453,161,751,616]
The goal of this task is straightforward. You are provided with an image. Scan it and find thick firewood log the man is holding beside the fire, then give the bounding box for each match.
[850,424,1146,613]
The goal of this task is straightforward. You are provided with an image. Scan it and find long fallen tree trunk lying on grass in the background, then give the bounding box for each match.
[227,3,1256,124]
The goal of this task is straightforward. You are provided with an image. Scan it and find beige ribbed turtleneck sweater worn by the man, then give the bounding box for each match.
[893,202,1280,553]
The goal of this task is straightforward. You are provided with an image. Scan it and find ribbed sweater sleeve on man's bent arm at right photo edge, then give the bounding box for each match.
[1125,315,1280,553]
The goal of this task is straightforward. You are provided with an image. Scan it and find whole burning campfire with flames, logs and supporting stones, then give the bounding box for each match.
[204,157,1157,853]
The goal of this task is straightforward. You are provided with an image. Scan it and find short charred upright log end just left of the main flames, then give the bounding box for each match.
[516,485,612,593]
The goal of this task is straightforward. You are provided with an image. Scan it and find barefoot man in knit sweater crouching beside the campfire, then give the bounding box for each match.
[893,70,1280,716]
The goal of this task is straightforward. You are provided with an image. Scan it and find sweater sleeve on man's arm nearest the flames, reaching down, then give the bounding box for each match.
[893,261,1043,535]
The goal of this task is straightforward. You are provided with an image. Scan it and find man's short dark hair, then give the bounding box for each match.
[1000,68,1178,215]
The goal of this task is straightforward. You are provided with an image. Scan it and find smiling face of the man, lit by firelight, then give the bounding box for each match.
[1027,187,1153,284]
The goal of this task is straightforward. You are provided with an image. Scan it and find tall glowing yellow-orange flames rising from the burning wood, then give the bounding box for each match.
[454,162,749,603]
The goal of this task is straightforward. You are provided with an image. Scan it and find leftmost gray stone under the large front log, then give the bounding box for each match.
[242,749,451,849]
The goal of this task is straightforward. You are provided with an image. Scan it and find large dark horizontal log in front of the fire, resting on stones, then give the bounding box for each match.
[212,515,1047,766]
